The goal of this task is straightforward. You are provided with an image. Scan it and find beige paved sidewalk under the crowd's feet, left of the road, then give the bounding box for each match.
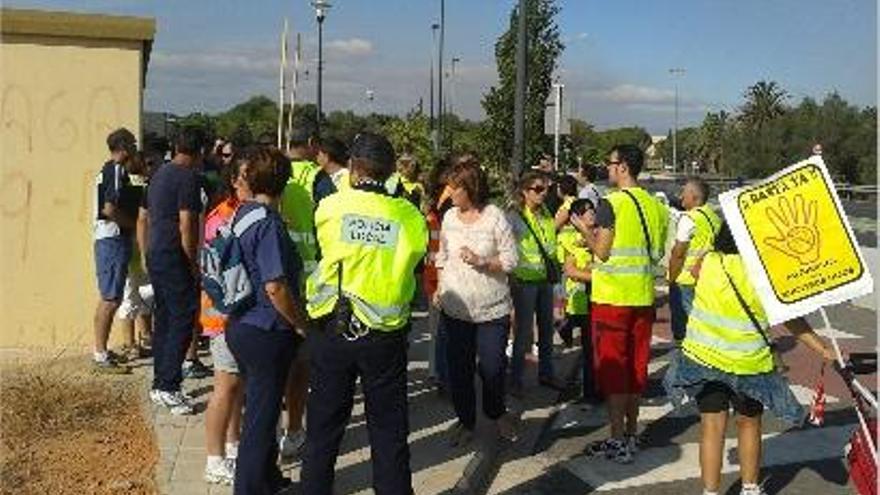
[147,315,577,495]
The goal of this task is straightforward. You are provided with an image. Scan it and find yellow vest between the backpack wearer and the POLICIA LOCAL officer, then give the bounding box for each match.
[280,160,320,275]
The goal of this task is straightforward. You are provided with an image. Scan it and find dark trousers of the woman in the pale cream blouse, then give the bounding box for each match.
[442,314,510,430]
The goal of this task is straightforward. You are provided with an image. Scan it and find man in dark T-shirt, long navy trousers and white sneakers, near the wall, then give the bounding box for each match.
[142,129,206,414]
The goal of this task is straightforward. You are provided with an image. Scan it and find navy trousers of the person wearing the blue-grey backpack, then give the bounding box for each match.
[226,320,301,495]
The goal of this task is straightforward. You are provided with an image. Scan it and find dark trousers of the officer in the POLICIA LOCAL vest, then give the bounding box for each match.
[302,319,412,495]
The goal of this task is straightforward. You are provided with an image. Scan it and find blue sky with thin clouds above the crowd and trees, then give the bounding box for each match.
[5,0,877,134]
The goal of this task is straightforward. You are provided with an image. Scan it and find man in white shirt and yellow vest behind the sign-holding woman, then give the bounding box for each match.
[669,177,723,342]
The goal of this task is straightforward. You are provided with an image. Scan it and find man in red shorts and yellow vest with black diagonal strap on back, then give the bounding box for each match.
[572,144,668,464]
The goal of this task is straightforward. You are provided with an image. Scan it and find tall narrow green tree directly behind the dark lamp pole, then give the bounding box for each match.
[482,0,564,180]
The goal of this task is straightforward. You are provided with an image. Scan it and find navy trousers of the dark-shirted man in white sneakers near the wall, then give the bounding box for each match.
[147,251,199,392]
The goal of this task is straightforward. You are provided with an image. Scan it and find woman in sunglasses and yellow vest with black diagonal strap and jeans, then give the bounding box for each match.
[510,171,565,398]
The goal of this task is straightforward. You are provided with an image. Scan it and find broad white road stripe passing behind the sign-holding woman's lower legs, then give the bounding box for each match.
[564,426,854,492]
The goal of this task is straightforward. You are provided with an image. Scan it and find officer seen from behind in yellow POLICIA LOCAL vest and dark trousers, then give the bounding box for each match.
[302,133,428,495]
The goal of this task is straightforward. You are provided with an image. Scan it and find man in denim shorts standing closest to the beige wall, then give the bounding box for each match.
[93,128,138,374]
